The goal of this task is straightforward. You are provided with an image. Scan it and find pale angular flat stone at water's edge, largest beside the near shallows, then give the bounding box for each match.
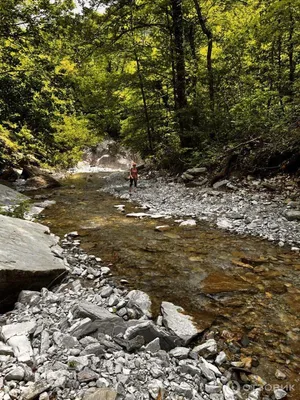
[161,301,202,345]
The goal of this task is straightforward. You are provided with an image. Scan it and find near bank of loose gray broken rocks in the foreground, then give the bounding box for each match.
[0,232,278,400]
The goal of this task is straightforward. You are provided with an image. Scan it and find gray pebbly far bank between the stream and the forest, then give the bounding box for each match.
[104,173,300,252]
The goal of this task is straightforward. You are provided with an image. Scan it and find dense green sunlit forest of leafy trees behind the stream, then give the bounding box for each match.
[0,0,300,172]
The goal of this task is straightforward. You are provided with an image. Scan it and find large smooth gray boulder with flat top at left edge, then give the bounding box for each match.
[0,215,66,312]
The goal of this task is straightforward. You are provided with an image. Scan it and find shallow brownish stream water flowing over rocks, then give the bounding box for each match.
[36,174,300,400]
